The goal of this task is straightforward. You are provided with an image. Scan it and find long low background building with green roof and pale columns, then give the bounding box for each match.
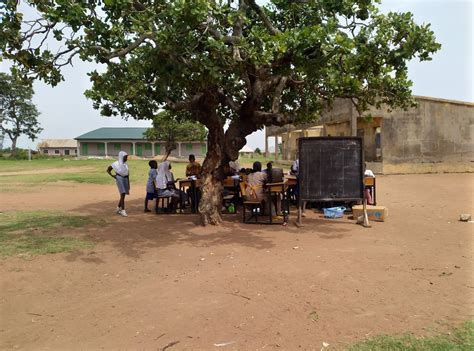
[75,128,207,158]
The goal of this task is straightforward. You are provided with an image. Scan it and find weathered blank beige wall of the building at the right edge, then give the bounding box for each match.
[381,99,474,173]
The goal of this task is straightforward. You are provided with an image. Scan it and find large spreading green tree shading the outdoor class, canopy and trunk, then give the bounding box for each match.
[0,0,440,224]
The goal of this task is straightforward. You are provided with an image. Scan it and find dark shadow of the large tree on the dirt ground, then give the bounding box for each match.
[69,200,350,263]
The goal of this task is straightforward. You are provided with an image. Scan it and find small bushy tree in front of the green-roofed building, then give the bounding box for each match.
[145,111,207,161]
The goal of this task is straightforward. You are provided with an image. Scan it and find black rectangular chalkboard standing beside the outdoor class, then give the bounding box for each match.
[298,137,364,201]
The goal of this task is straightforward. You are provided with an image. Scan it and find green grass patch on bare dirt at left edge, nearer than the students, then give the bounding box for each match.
[0,211,99,257]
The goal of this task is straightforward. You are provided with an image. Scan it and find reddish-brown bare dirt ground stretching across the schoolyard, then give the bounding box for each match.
[0,174,474,350]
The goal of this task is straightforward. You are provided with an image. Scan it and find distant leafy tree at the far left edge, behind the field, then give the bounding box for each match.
[0,73,43,155]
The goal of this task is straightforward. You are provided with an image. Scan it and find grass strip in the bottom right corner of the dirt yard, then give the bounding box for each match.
[348,321,474,351]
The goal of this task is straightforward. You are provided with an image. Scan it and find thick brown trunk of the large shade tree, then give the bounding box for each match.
[199,114,225,225]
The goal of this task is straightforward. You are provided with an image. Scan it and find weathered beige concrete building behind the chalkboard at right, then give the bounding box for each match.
[265,96,474,174]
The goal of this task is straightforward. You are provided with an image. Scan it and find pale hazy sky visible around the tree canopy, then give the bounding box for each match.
[0,0,474,149]
